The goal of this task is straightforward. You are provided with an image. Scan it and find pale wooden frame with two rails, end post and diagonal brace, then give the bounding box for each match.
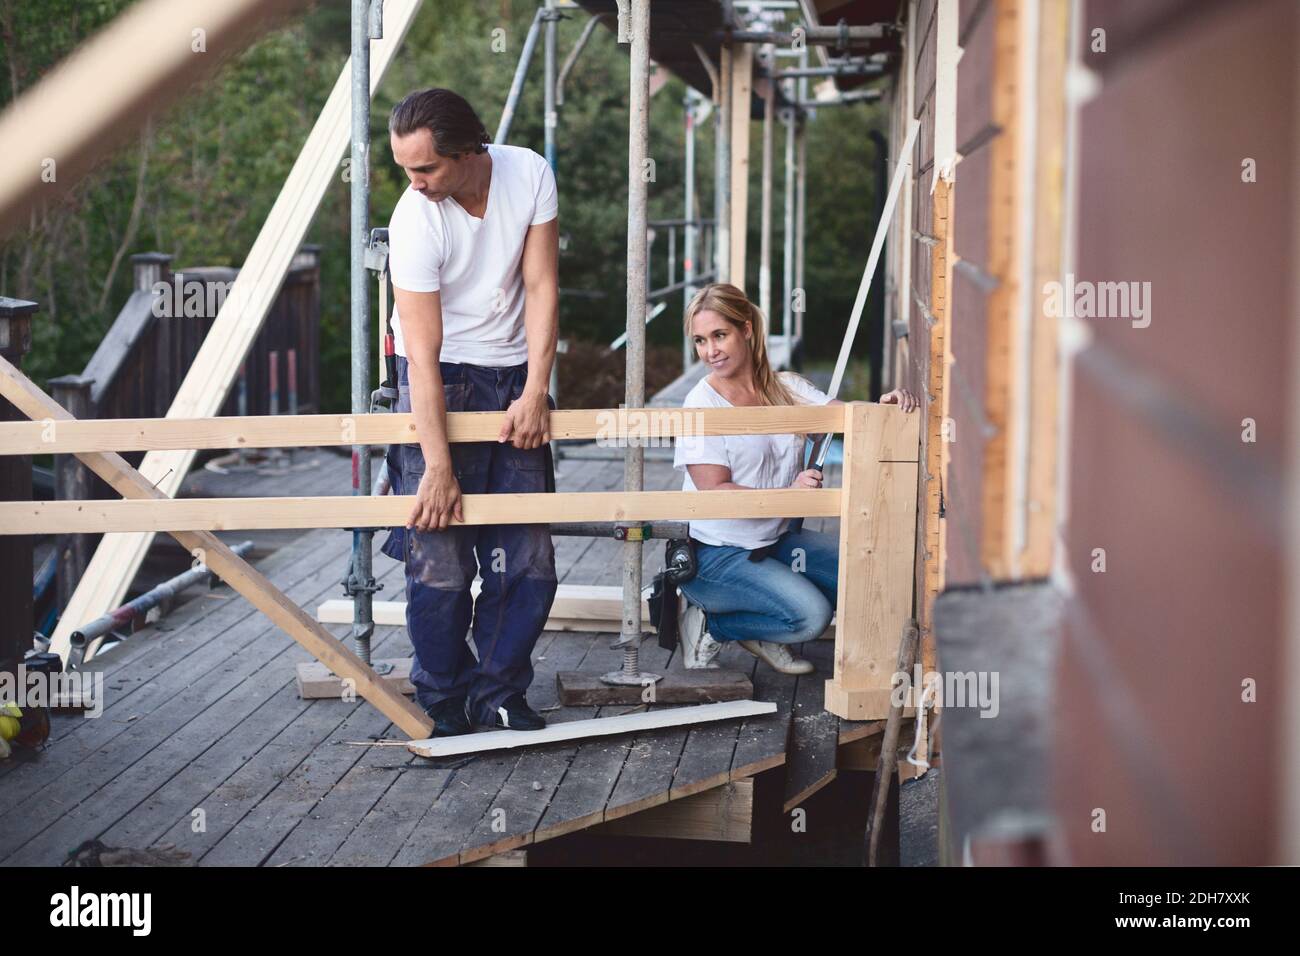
[0,362,920,723]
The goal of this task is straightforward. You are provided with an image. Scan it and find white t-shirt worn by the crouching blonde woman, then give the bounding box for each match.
[672,372,831,550]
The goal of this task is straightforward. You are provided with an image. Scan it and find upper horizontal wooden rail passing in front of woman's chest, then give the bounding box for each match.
[0,405,844,455]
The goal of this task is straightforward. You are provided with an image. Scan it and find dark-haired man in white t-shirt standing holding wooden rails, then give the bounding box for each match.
[385,88,559,736]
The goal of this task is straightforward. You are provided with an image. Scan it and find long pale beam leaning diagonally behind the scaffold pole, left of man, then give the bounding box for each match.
[50,0,420,671]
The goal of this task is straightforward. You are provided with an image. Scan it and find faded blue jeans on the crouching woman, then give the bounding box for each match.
[680,531,840,644]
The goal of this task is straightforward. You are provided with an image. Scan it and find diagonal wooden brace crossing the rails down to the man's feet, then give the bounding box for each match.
[0,358,433,740]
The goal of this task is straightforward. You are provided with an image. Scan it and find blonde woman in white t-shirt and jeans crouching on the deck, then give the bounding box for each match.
[673,282,917,674]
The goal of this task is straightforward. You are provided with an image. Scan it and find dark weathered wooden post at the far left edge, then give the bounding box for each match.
[0,297,36,672]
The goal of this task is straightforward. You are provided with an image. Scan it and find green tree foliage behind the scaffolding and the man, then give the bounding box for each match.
[0,0,876,410]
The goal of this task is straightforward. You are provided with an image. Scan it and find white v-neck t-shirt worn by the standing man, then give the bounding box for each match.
[389,146,558,368]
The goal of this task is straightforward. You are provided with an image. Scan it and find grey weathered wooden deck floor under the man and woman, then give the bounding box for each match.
[0,452,849,865]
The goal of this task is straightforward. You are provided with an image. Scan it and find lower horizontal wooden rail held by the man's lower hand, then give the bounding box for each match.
[0,488,840,535]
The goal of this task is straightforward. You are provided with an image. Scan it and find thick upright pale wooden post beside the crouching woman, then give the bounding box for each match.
[826,402,922,721]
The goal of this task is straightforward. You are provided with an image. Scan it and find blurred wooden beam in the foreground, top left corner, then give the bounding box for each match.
[0,0,308,234]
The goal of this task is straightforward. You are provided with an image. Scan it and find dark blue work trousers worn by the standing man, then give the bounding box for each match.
[384,356,556,723]
